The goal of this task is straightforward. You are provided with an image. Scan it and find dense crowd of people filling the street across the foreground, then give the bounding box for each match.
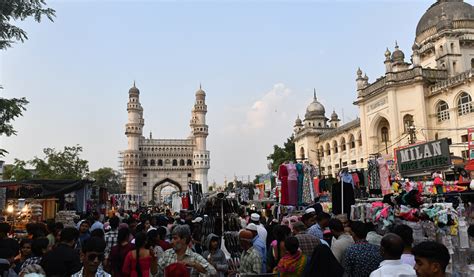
[0,198,462,277]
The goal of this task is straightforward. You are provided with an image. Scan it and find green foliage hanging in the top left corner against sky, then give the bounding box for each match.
[0,0,55,49]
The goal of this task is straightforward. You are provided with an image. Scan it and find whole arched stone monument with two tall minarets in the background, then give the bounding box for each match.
[122,84,210,203]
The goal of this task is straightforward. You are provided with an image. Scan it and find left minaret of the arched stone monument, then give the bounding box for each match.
[123,82,145,194]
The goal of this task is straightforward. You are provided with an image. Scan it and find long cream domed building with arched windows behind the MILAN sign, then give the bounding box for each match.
[294,0,474,175]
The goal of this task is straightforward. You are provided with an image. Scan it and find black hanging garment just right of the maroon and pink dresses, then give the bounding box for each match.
[332,172,355,216]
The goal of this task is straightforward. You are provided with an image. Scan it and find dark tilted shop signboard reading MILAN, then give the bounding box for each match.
[396,138,451,174]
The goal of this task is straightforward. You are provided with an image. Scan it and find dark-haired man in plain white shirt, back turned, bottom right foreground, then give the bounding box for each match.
[370,233,416,277]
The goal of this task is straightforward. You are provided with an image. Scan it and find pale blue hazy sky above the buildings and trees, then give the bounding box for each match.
[0,0,448,182]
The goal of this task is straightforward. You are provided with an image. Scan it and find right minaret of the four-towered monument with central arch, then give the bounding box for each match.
[190,85,210,192]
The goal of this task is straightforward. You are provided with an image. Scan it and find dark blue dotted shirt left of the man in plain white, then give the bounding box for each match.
[342,241,383,277]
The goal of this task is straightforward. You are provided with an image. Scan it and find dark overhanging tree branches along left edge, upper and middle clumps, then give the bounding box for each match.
[0,0,55,157]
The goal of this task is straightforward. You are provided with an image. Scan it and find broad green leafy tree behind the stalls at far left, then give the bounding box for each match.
[29,145,89,179]
